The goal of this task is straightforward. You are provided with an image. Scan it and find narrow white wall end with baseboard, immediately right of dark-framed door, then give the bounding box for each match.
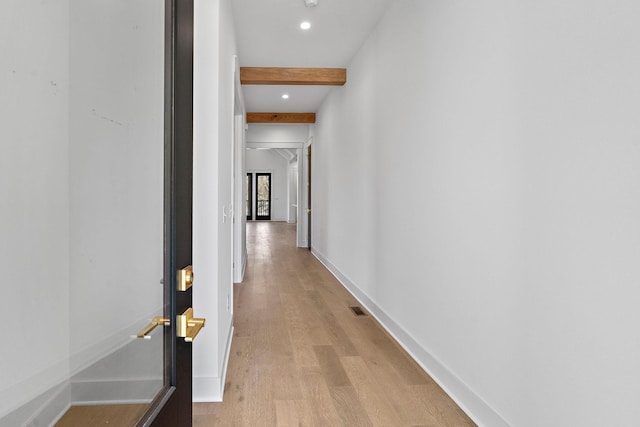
[193,0,236,401]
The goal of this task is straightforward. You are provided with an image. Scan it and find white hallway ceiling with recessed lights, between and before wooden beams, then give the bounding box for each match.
[231,0,394,112]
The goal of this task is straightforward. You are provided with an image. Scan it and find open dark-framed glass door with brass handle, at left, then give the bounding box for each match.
[0,0,193,426]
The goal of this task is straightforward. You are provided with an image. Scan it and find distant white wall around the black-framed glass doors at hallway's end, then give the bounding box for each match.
[245,150,289,221]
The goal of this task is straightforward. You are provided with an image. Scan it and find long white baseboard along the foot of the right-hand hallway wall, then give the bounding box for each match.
[311,248,509,427]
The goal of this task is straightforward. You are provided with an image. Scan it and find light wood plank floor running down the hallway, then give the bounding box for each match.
[193,222,475,427]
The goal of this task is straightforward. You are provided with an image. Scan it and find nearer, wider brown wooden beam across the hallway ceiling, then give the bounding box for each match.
[240,67,347,86]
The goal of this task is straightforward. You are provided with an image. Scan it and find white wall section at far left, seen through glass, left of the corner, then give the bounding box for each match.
[0,0,69,421]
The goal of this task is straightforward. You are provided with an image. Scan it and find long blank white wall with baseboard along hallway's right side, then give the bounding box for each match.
[312,0,640,426]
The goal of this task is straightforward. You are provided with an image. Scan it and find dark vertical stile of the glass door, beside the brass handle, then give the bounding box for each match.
[137,0,193,427]
